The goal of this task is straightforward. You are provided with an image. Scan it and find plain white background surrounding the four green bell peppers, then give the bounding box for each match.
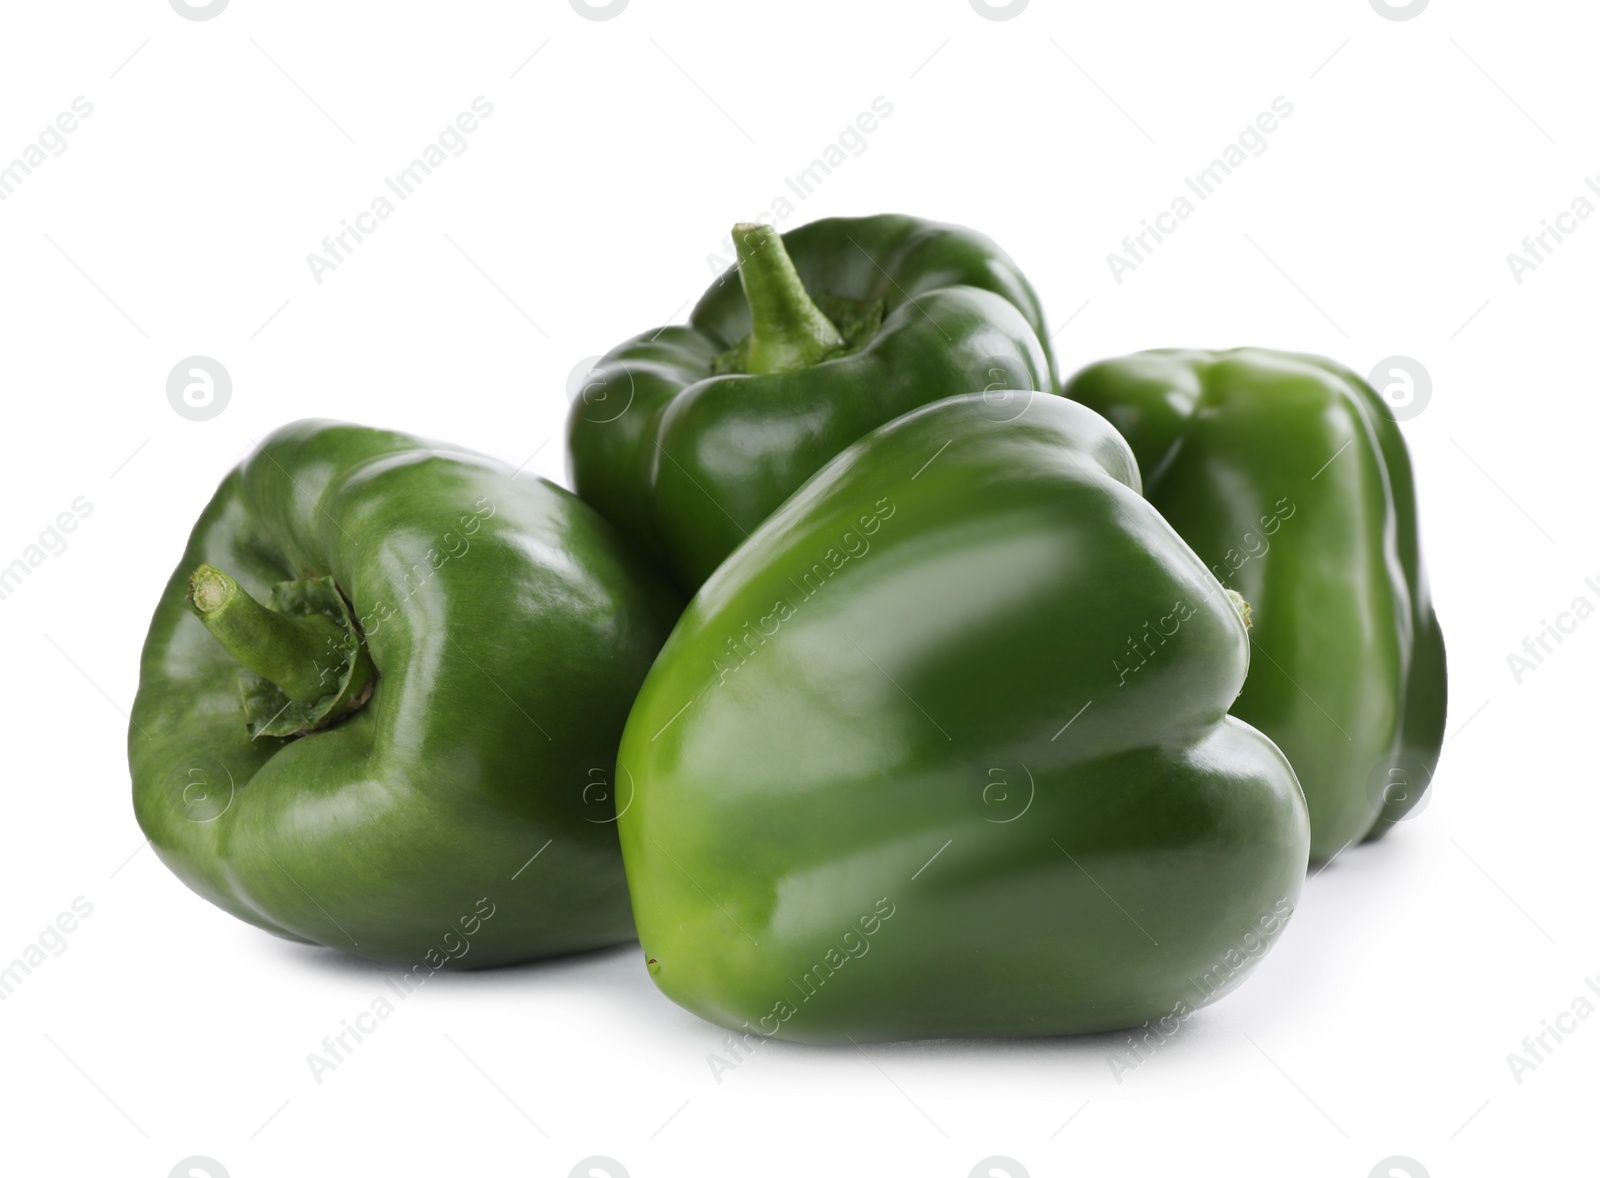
[0,0,1600,1178]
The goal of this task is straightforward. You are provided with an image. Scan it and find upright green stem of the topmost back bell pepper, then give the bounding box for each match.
[733,222,845,373]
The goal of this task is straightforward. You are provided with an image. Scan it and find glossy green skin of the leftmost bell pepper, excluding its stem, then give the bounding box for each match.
[128,421,677,970]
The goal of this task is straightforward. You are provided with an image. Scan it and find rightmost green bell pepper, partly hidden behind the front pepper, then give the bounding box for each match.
[1064,349,1446,859]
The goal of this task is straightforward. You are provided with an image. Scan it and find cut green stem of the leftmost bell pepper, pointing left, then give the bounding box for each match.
[189,565,342,703]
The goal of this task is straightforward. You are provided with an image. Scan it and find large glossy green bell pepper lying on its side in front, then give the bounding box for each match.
[618,394,1307,1042]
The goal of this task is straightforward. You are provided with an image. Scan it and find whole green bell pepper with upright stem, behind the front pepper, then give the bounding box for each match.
[568,216,1054,592]
